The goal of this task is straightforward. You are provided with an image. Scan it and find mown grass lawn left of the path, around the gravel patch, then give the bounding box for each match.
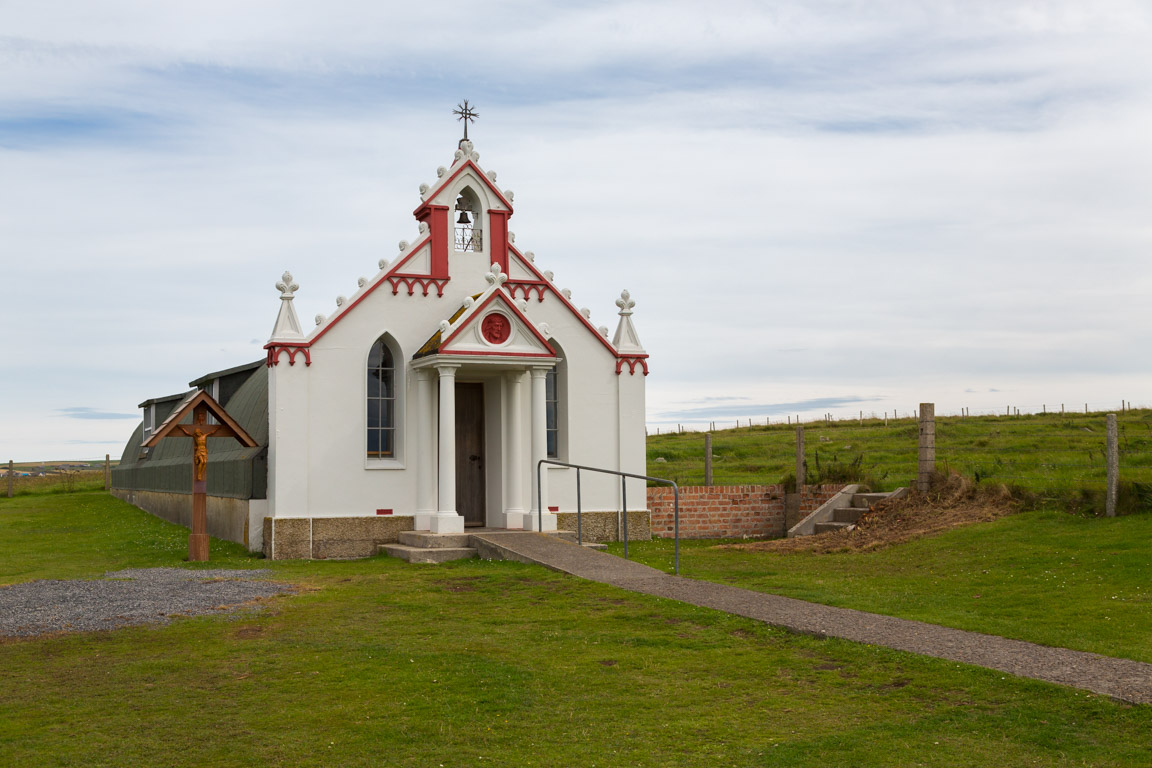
[0,493,1152,768]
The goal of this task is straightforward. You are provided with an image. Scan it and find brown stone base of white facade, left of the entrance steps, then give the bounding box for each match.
[264,515,414,560]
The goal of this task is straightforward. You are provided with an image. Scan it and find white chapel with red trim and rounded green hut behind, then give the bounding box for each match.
[113,138,649,558]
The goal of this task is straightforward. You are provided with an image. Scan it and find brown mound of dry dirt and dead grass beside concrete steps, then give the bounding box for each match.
[719,474,1022,553]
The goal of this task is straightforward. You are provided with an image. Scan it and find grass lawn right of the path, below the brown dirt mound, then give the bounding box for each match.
[612,509,1152,662]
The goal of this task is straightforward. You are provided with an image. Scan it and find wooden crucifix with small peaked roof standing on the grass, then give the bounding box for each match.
[144,389,259,562]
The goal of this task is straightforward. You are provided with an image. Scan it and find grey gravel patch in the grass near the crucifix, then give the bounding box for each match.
[0,568,293,637]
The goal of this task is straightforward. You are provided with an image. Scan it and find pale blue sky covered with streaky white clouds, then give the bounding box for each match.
[0,0,1152,461]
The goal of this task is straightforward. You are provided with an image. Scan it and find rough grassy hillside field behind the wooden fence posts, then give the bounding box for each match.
[647,409,1152,508]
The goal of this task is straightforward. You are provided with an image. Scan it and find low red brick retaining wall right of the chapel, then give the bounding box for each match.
[647,484,844,539]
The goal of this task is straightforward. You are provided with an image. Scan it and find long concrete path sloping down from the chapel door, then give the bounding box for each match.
[473,532,1152,704]
